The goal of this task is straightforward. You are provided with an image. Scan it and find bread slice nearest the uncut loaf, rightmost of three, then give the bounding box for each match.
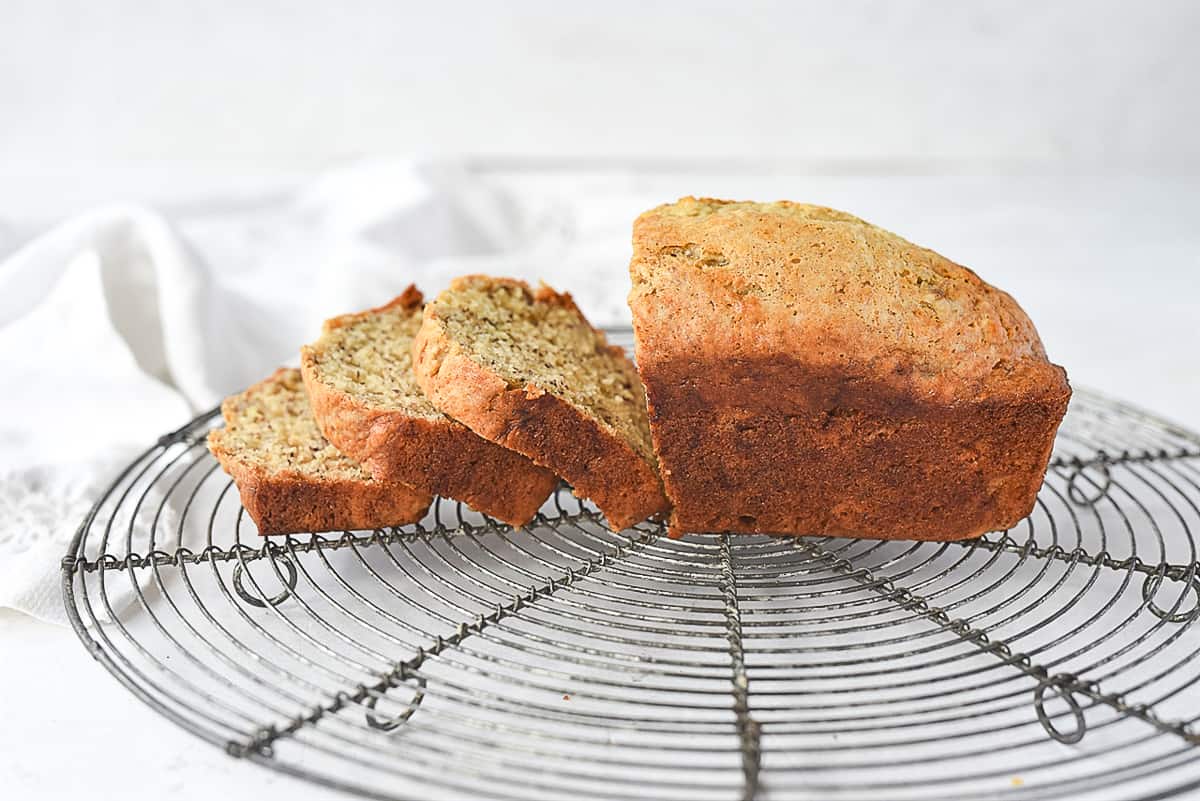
[413,276,667,529]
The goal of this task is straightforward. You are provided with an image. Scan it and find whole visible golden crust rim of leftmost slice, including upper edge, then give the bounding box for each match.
[208,368,433,536]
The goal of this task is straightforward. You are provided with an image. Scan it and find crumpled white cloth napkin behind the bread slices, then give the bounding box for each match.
[0,162,629,622]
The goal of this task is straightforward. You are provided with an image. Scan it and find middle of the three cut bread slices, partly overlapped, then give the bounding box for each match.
[300,287,558,526]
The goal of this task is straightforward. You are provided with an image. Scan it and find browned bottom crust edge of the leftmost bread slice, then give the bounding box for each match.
[228,464,433,536]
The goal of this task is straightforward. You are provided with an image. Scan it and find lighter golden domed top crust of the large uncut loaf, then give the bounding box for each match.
[629,197,1069,402]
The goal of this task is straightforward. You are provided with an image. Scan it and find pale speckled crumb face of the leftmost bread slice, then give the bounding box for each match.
[209,368,373,483]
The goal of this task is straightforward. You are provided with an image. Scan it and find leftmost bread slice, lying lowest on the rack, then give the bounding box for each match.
[209,368,433,536]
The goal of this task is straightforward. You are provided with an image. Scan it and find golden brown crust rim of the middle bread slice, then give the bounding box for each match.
[300,287,558,526]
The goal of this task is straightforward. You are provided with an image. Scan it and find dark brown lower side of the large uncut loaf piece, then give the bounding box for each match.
[643,362,1070,540]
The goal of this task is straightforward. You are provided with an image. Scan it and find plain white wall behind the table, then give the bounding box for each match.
[0,0,1200,173]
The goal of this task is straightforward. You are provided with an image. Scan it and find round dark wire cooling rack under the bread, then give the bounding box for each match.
[62,340,1200,801]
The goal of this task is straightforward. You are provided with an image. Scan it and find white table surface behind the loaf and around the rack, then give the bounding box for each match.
[0,165,1200,801]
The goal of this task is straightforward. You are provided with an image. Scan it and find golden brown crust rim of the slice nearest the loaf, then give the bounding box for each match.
[413,276,667,530]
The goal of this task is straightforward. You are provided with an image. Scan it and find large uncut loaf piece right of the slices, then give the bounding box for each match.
[629,198,1070,540]
